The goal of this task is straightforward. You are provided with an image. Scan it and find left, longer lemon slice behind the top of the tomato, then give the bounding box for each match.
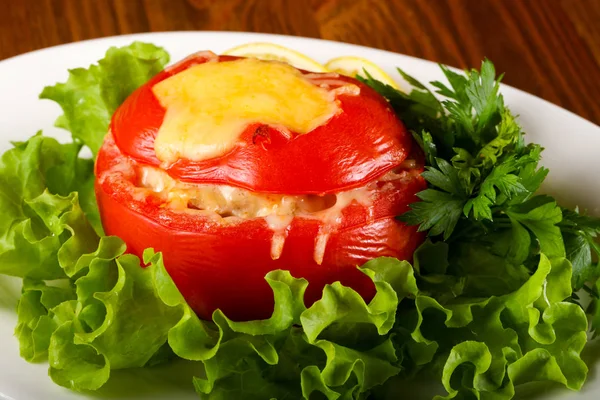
[222,43,327,72]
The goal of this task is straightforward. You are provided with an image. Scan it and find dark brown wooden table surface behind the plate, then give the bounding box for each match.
[0,0,600,124]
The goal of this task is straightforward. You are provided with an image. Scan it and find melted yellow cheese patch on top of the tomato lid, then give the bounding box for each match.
[152,58,342,165]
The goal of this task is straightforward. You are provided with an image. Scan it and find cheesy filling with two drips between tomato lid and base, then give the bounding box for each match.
[138,167,374,265]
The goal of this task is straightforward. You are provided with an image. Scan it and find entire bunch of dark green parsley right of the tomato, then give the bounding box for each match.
[363,60,600,330]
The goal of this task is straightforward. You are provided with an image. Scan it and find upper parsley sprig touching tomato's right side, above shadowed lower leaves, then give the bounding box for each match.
[367,60,548,240]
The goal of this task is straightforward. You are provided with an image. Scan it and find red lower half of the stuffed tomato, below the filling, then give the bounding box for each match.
[96,137,426,320]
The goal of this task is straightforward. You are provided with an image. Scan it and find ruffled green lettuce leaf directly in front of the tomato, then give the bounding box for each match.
[164,253,416,399]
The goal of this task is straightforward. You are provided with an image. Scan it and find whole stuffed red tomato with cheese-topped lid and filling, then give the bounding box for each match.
[96,52,425,320]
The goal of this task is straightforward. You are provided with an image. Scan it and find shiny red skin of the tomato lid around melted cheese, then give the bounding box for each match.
[111,55,413,194]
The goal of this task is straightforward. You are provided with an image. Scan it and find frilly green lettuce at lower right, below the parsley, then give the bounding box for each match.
[401,255,588,399]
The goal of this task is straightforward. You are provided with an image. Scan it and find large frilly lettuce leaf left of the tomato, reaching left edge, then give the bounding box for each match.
[0,135,188,390]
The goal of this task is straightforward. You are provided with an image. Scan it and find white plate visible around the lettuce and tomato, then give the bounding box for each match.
[0,32,600,400]
